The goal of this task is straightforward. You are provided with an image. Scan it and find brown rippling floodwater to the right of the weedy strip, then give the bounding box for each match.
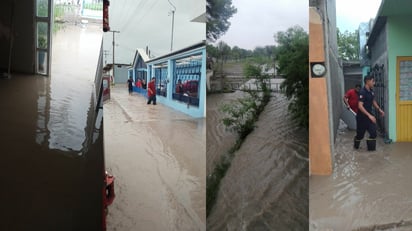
[207,94,309,230]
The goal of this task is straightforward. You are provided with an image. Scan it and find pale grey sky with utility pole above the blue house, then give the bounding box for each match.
[103,0,206,64]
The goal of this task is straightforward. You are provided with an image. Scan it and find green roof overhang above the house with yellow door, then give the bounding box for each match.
[367,0,412,45]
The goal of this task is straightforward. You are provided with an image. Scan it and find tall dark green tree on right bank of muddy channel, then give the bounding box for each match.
[275,26,309,128]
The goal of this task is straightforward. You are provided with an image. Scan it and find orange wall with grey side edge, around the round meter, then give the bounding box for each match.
[309,0,344,175]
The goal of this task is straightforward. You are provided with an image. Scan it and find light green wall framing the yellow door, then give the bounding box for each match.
[387,15,412,141]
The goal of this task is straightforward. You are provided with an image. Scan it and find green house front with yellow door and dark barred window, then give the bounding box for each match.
[361,0,412,142]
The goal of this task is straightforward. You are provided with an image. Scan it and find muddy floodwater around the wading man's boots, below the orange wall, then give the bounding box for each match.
[310,124,412,230]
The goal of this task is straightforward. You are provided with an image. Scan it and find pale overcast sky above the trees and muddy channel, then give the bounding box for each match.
[214,0,309,49]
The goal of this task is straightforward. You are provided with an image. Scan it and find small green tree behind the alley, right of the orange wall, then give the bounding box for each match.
[337,28,359,61]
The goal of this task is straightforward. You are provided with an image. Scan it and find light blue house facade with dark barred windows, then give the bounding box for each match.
[129,42,206,118]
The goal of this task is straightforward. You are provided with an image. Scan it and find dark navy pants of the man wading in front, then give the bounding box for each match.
[354,114,377,151]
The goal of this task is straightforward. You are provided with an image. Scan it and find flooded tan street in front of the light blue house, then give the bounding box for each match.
[104,85,206,231]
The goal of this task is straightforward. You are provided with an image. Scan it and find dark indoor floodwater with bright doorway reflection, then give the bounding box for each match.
[0,24,104,230]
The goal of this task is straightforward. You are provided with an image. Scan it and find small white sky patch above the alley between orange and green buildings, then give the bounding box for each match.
[336,0,381,32]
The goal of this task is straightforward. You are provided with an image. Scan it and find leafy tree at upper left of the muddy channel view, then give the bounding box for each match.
[206,0,237,41]
